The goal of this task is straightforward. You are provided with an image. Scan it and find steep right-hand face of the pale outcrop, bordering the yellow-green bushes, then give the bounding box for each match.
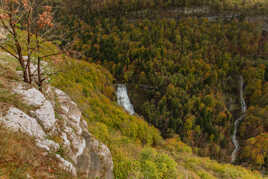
[48,88,113,179]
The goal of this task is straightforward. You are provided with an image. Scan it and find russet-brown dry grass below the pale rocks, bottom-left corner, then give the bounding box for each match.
[0,126,72,179]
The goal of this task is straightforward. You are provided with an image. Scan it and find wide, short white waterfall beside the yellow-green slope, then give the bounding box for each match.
[116,84,135,115]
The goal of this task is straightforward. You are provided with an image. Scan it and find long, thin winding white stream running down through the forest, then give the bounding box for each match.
[231,76,247,163]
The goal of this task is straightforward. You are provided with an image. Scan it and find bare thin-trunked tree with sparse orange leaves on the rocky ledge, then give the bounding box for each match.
[0,0,56,91]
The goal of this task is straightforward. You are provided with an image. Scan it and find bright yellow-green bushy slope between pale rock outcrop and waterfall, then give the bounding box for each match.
[49,55,266,178]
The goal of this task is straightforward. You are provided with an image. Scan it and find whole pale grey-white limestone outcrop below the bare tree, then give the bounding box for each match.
[0,83,113,179]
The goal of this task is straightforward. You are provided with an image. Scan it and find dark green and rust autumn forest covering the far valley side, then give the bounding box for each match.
[49,0,268,169]
